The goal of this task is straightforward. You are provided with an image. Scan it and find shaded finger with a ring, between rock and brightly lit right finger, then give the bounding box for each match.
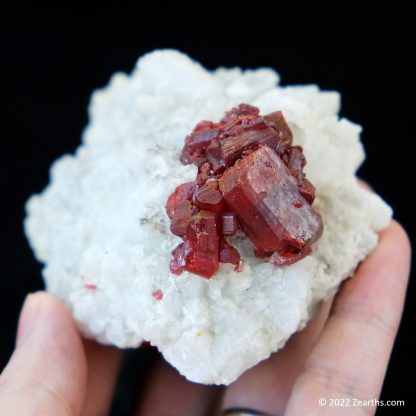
[222,298,332,414]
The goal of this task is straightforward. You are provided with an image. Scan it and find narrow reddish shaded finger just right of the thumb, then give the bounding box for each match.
[82,340,122,416]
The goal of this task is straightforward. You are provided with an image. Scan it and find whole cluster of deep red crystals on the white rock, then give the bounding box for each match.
[166,104,323,278]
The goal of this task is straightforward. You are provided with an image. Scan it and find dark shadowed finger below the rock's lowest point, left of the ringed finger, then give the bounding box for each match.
[135,352,222,416]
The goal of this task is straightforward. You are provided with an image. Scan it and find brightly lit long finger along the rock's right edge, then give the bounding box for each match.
[285,222,410,415]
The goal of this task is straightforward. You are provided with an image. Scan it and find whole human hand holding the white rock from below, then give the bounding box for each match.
[0,222,410,416]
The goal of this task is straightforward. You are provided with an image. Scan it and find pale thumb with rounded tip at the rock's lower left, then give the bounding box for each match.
[0,292,86,416]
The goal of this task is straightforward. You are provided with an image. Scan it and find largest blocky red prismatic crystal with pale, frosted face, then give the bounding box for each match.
[219,145,322,256]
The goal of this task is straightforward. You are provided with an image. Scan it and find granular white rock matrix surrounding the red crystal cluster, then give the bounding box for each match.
[25,50,391,384]
